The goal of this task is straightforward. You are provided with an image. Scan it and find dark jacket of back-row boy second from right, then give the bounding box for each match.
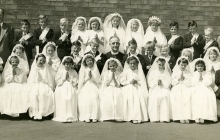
[183,33,205,59]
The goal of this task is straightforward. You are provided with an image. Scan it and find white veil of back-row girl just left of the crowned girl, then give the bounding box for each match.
[126,18,144,48]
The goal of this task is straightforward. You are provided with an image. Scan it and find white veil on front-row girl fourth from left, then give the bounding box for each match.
[78,54,100,90]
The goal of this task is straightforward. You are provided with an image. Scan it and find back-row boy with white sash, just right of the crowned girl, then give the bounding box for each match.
[166,21,183,59]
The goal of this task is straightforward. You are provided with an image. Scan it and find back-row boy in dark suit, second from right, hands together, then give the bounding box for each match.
[183,21,205,59]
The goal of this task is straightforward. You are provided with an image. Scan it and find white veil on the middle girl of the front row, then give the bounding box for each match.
[100,58,123,87]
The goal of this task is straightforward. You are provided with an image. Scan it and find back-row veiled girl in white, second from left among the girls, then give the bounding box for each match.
[85,17,104,53]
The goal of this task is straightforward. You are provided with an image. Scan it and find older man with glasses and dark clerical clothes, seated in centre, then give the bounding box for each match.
[106,36,124,63]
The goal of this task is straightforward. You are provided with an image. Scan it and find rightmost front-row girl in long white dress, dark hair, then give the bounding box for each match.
[192,58,217,123]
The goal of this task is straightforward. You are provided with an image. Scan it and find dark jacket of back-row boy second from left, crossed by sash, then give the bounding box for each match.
[33,27,54,53]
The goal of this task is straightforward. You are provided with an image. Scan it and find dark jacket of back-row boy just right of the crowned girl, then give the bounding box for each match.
[166,35,183,59]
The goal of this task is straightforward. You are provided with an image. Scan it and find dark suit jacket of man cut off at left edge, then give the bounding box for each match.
[0,22,14,64]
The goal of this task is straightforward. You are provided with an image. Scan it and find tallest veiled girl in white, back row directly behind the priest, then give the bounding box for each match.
[104,13,127,53]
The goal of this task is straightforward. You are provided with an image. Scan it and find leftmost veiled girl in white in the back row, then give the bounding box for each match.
[70,17,88,56]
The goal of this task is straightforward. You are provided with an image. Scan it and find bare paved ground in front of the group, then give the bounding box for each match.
[0,115,220,140]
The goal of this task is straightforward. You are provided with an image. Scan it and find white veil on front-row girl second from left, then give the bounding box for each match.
[28,53,55,90]
